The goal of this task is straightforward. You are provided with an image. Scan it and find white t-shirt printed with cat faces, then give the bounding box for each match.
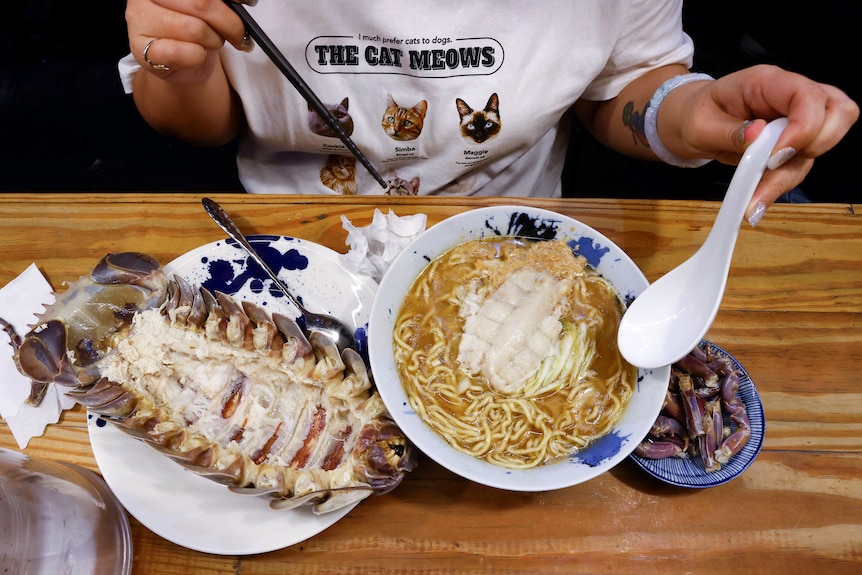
[121,0,693,197]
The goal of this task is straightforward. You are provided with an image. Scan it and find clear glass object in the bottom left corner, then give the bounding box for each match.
[0,448,132,575]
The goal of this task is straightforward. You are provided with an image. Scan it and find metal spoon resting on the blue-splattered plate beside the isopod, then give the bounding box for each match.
[201,198,357,351]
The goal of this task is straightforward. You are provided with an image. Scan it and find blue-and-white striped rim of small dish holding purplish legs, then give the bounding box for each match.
[630,340,766,488]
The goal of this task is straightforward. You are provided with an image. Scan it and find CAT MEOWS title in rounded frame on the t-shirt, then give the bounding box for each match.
[305,33,504,78]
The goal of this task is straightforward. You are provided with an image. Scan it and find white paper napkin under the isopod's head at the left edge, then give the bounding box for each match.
[0,264,75,449]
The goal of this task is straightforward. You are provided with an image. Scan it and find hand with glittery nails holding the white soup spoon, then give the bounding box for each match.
[678,66,859,225]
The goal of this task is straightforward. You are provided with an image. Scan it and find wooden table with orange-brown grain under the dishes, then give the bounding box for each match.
[0,194,862,575]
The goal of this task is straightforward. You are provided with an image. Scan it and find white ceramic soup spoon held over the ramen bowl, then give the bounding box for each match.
[617,118,787,369]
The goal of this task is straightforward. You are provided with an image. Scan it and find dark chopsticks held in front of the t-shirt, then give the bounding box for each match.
[224,0,389,189]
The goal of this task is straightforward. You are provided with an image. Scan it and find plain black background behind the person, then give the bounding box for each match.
[0,0,862,202]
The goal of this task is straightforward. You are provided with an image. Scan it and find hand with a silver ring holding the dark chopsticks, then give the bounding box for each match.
[126,0,253,84]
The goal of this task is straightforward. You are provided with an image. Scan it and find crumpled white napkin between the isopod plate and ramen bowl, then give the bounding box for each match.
[339,208,427,282]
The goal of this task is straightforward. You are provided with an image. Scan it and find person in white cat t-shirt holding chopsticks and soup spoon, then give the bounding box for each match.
[120,0,859,224]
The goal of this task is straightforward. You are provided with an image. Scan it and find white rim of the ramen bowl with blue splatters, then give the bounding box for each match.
[368,206,670,491]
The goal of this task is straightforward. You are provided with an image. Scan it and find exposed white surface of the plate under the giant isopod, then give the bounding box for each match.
[87,235,377,555]
